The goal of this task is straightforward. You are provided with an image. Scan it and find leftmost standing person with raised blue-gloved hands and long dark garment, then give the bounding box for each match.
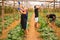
[20,7,28,31]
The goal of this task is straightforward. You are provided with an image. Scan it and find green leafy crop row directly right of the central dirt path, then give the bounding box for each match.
[38,16,58,40]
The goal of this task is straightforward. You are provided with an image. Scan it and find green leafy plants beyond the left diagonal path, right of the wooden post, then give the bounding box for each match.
[4,14,19,29]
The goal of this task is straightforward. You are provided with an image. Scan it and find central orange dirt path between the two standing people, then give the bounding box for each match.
[26,14,41,40]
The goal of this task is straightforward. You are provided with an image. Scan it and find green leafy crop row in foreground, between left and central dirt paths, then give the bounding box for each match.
[6,25,24,40]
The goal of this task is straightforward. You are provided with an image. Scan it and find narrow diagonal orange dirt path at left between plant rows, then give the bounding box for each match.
[0,20,20,39]
